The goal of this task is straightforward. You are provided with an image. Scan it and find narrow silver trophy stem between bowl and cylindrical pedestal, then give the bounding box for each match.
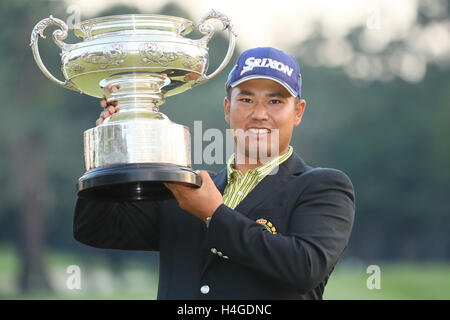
[100,72,170,122]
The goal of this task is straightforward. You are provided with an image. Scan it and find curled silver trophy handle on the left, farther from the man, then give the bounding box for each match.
[30,15,81,92]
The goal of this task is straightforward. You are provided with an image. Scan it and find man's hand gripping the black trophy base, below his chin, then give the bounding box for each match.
[164,171,223,222]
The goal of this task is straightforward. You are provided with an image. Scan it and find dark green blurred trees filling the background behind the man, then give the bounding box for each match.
[0,1,450,290]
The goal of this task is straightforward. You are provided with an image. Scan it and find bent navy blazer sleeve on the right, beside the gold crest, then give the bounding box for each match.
[206,168,355,294]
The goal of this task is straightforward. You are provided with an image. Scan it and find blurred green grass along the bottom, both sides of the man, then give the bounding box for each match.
[0,246,450,300]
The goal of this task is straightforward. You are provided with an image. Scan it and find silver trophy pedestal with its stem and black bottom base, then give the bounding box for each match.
[78,73,201,201]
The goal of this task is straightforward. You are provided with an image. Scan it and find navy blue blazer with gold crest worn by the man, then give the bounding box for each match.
[73,152,355,299]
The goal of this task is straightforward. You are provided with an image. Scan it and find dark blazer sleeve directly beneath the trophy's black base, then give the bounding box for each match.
[73,198,161,250]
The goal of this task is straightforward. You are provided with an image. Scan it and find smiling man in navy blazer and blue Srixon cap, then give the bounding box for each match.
[74,48,354,299]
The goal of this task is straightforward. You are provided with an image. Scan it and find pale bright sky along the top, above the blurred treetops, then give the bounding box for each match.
[59,0,450,82]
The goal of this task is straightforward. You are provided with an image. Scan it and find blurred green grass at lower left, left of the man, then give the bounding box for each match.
[0,246,158,300]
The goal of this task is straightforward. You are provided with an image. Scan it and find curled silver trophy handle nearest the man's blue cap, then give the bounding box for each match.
[195,10,236,85]
